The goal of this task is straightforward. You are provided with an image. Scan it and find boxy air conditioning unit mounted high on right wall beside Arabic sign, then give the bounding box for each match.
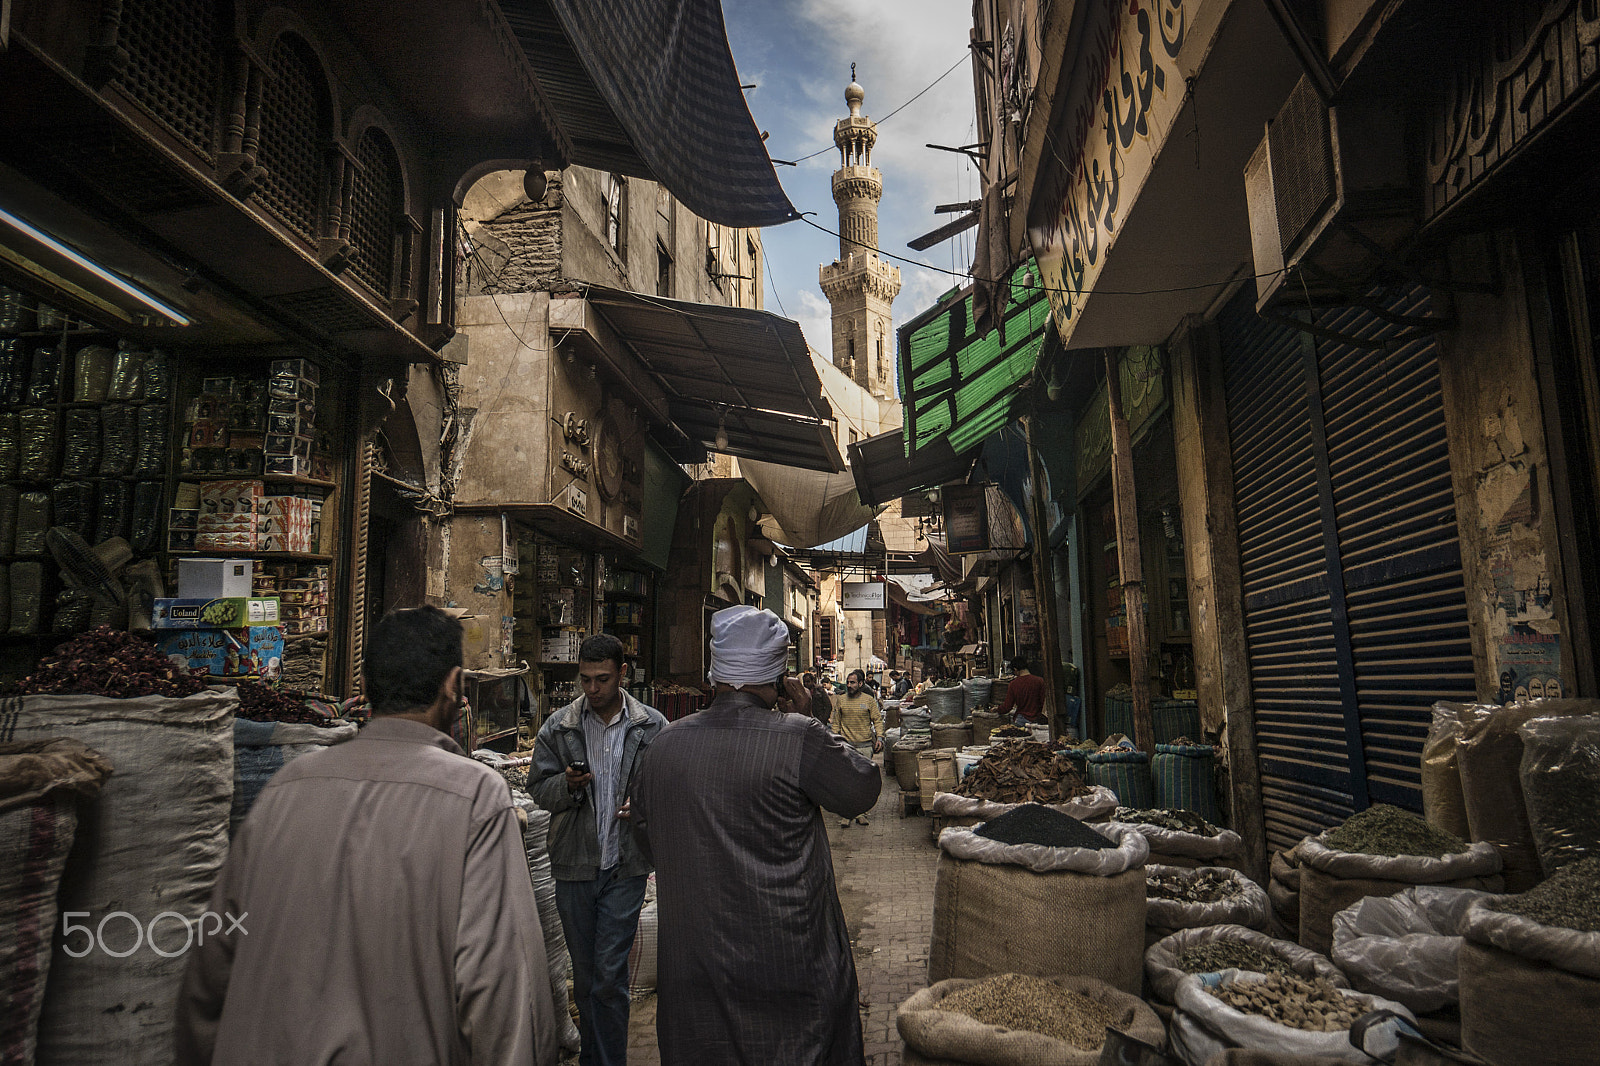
[1245,78,1418,311]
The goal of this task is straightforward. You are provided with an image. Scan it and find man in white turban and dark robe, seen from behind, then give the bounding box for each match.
[632,607,883,1066]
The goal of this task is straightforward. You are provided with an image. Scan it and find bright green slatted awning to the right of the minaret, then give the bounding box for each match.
[899,259,1050,458]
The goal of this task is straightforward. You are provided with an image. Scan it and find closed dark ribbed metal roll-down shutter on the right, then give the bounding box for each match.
[1218,281,1474,848]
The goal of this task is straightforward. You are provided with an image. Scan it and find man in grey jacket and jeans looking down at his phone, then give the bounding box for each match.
[528,634,667,1066]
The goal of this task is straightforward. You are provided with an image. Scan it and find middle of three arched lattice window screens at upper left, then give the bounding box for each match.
[259,35,328,243]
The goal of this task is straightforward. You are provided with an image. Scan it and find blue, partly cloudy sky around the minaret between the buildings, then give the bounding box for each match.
[723,0,981,364]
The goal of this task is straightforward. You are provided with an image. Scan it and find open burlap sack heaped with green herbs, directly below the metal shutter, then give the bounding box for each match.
[1299,804,1501,954]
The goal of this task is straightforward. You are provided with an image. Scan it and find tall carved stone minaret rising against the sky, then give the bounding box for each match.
[819,64,901,397]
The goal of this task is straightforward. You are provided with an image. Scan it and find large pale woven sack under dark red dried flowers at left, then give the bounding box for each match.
[0,685,238,1066]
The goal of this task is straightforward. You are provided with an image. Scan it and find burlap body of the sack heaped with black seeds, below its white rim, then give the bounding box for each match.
[928,851,1144,994]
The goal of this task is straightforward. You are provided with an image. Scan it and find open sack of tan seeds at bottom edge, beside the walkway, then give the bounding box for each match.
[894,973,1166,1066]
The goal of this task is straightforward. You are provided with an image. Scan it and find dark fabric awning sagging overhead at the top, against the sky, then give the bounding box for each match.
[499,0,797,226]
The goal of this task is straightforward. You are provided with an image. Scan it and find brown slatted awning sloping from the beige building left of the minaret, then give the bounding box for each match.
[550,287,845,472]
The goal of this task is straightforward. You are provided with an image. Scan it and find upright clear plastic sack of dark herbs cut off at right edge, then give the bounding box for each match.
[1518,717,1600,877]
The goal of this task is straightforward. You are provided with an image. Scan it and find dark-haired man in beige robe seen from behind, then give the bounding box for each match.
[178,607,558,1066]
